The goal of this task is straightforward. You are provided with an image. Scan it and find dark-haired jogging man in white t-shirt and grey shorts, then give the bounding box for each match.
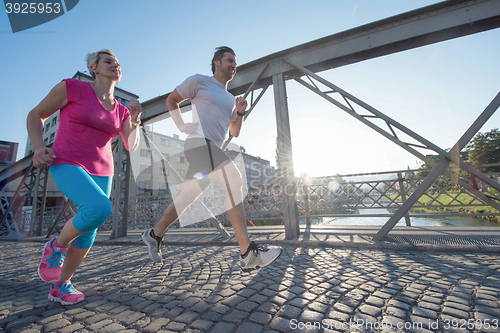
[142,46,281,270]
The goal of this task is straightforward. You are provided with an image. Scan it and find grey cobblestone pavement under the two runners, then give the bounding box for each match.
[0,242,500,333]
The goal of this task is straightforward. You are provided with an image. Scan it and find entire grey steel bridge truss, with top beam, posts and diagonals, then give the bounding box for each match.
[0,0,500,240]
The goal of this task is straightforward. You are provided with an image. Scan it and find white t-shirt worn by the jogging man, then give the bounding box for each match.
[176,74,237,146]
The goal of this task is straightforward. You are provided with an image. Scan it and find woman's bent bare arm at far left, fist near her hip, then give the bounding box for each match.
[26,81,68,168]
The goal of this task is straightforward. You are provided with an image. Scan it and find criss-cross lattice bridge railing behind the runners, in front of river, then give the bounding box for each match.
[98,163,500,230]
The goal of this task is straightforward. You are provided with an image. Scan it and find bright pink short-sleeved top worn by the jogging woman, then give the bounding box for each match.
[49,79,130,177]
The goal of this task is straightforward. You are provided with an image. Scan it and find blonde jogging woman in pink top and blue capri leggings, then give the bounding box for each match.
[27,50,142,305]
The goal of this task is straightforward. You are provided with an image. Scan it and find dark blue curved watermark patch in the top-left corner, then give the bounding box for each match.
[4,0,79,33]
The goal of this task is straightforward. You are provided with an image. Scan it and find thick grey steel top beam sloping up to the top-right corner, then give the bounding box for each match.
[228,0,500,95]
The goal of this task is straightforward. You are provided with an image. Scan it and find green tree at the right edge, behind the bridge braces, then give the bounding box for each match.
[465,128,500,173]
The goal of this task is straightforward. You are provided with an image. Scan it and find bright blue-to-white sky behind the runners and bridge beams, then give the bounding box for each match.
[0,0,500,176]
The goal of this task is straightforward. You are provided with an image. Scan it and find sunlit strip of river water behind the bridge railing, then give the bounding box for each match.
[300,209,500,227]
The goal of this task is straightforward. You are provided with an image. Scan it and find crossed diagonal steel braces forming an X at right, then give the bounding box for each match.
[285,60,500,241]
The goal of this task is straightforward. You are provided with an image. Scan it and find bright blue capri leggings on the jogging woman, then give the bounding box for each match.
[50,164,113,249]
